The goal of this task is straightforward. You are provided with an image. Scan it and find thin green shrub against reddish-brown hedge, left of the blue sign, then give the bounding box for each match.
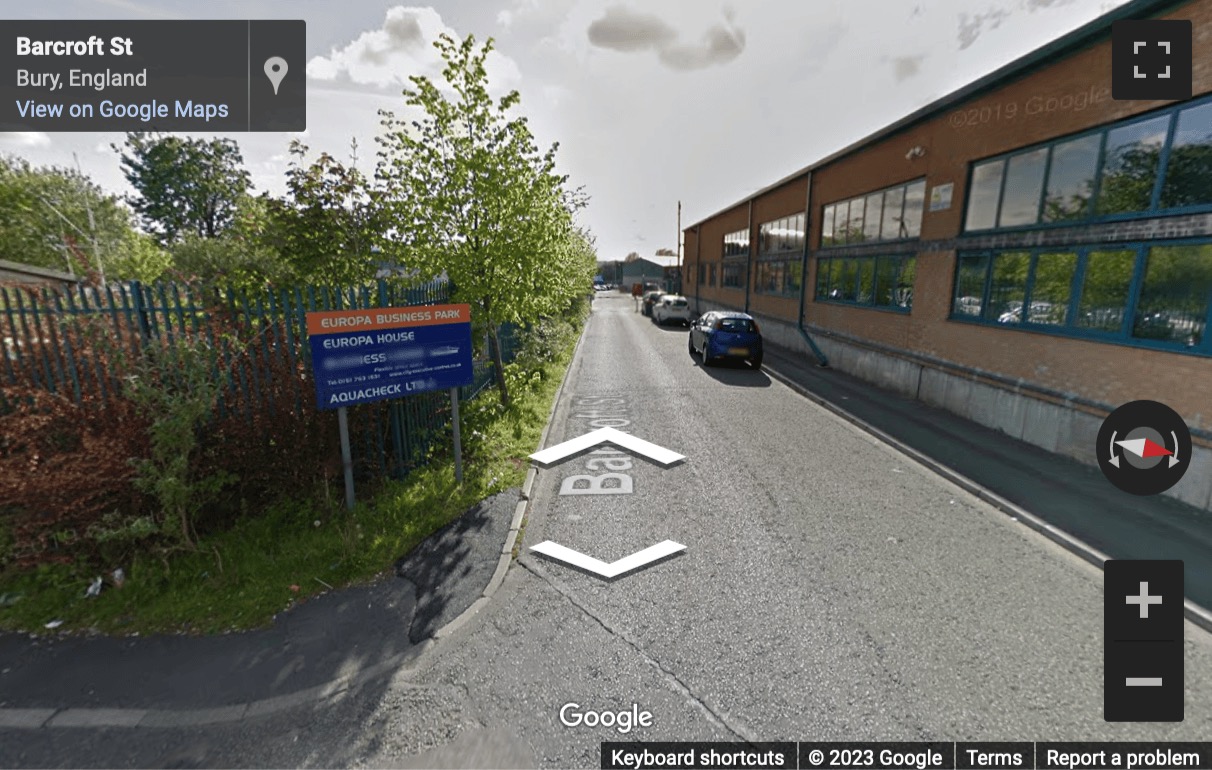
[127,337,235,549]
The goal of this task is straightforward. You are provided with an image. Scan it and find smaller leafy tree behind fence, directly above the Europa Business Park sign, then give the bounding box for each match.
[275,139,384,285]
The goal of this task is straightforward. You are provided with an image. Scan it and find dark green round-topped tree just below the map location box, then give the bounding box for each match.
[114,132,252,244]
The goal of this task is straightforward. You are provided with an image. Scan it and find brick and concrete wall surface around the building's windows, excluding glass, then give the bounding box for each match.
[686,0,1212,507]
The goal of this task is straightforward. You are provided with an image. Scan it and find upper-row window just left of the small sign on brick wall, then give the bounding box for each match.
[821,179,926,249]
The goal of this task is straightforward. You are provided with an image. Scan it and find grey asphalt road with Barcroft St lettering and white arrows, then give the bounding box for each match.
[9,295,1212,768]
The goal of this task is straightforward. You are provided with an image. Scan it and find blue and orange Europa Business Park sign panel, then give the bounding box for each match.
[307,304,473,409]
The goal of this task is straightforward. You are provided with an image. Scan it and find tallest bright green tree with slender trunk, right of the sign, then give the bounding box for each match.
[377,35,593,406]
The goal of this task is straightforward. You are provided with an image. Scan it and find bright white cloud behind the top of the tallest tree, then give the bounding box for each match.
[307,5,521,91]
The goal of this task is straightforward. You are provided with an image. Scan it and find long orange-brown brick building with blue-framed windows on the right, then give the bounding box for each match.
[684,0,1212,509]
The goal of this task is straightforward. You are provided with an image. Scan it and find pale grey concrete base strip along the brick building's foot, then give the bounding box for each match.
[697,301,1212,512]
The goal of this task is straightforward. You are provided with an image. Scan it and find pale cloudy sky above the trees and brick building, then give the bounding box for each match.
[0,0,1122,259]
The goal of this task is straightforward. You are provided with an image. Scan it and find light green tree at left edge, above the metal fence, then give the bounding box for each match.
[0,156,136,278]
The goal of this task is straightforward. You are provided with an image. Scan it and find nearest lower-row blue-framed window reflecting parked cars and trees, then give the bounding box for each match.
[950,240,1212,355]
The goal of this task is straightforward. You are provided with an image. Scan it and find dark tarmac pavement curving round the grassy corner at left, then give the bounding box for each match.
[0,489,519,722]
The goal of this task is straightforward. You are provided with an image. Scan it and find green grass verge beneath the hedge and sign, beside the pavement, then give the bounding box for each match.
[0,315,579,634]
